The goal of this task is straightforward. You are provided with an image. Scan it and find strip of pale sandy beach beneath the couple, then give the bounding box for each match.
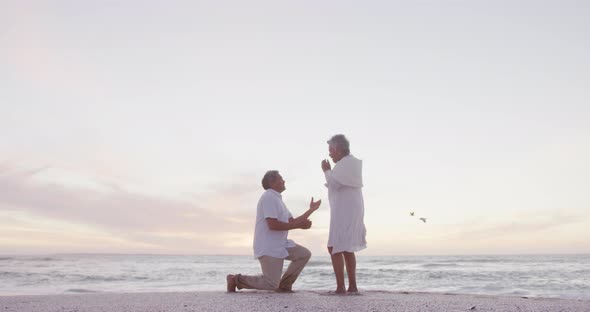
[0,291,590,312]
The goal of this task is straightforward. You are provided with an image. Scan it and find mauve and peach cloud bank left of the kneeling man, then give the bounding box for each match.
[0,164,262,253]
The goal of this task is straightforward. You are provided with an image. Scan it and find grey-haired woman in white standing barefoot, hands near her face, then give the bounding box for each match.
[322,134,367,294]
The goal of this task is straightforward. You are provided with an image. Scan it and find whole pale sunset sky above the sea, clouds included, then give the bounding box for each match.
[0,0,590,255]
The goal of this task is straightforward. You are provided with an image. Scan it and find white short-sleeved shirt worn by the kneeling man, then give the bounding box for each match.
[254,189,295,259]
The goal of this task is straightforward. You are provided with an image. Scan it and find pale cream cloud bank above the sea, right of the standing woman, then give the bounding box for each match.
[369,209,590,255]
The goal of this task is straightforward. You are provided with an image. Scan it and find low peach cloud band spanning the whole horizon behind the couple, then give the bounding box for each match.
[0,162,590,254]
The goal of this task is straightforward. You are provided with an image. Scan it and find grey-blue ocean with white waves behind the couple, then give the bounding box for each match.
[0,253,590,299]
